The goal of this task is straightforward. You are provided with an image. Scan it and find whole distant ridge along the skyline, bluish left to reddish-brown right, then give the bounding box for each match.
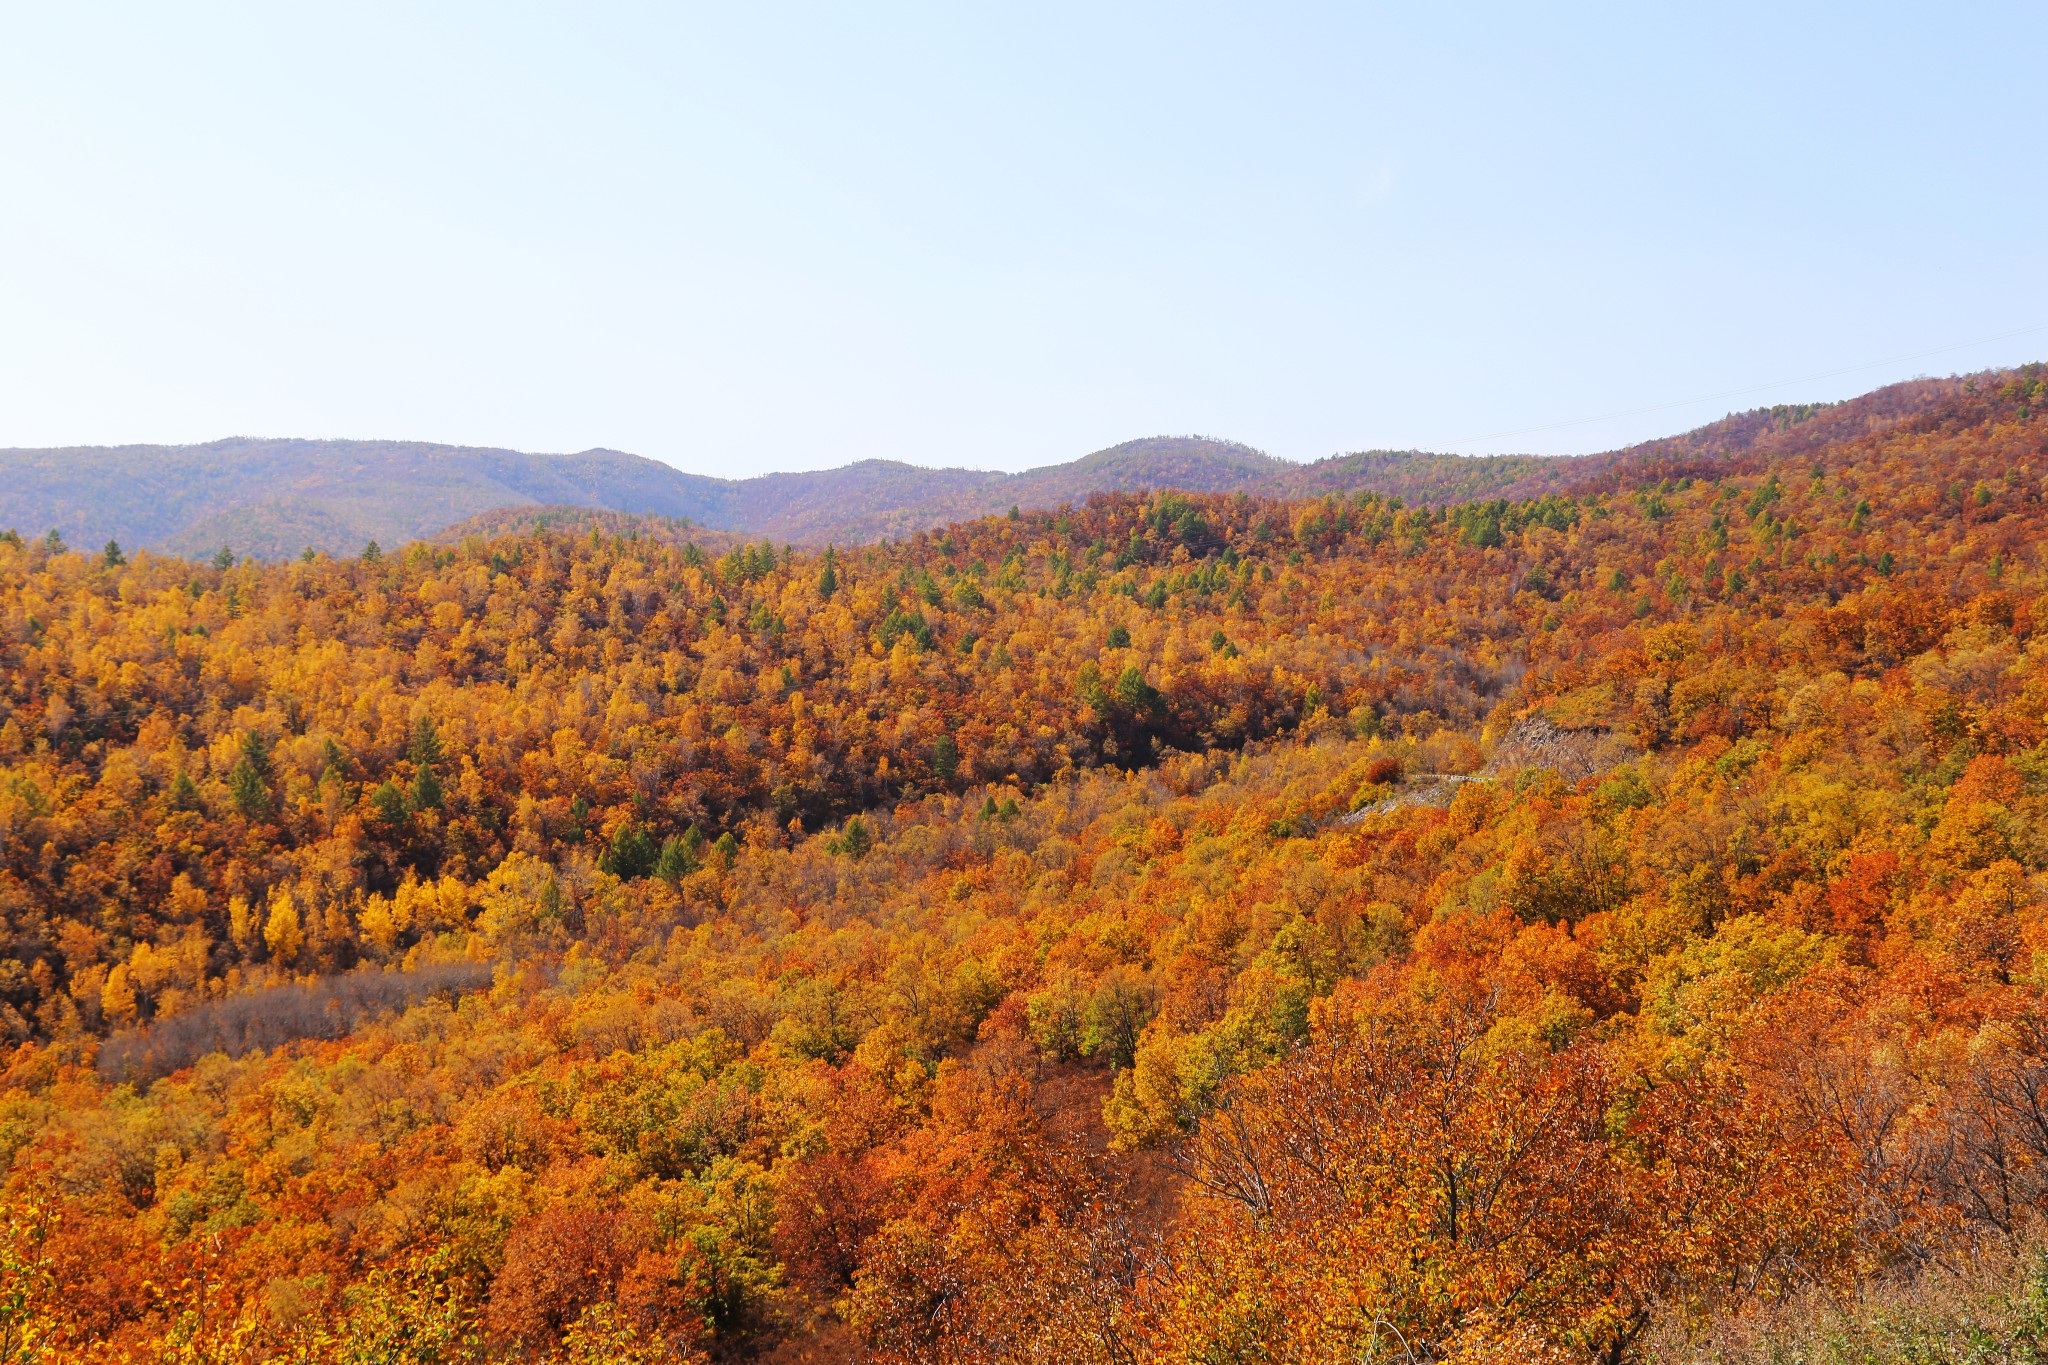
[0,379,1998,559]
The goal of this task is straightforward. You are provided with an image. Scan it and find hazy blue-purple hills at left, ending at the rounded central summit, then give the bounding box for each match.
[0,438,1296,561]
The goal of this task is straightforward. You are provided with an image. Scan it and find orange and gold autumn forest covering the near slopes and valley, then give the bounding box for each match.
[12,366,2048,1365]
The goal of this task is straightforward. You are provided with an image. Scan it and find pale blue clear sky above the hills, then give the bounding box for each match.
[0,0,2048,475]
